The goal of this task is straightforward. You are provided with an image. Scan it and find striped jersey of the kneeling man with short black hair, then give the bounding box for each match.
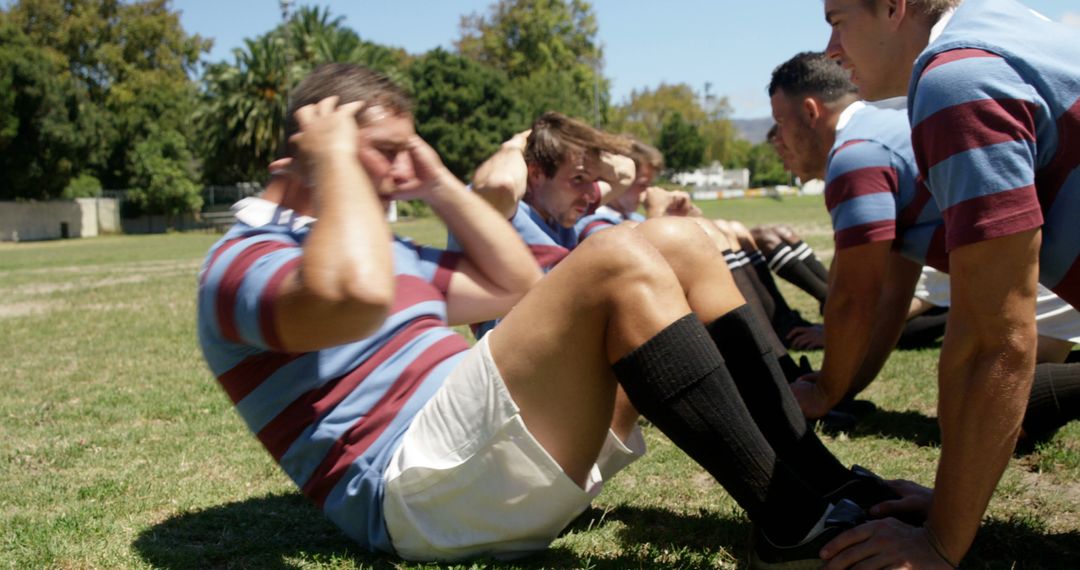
[825,101,948,270]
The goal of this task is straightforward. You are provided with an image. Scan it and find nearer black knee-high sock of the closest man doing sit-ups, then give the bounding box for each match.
[612,314,826,544]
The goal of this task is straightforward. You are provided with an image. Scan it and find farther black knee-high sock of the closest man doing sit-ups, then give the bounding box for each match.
[705,306,853,496]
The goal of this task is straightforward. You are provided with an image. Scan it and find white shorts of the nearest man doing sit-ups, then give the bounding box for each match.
[382,334,645,560]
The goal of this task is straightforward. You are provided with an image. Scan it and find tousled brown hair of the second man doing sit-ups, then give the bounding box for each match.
[525,111,631,177]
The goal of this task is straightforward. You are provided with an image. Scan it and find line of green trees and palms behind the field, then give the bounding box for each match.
[0,0,787,215]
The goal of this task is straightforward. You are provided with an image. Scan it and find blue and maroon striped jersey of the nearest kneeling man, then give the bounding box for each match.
[908,0,1080,307]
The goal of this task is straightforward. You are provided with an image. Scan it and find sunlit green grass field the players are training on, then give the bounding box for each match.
[0,193,1080,569]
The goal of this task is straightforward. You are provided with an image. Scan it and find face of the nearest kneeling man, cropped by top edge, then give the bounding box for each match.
[825,0,915,100]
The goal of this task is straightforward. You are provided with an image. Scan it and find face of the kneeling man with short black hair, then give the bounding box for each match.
[770,90,832,181]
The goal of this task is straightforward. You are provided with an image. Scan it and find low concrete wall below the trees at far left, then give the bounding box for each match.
[0,198,120,242]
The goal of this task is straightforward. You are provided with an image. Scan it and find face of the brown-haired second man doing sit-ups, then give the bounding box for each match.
[526,155,599,228]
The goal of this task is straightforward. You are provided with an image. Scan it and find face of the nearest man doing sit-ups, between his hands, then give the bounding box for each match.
[360,111,416,201]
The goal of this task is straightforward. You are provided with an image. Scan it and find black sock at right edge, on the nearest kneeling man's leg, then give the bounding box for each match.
[1023,364,1080,440]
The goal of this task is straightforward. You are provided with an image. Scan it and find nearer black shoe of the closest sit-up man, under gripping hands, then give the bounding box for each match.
[750,500,866,570]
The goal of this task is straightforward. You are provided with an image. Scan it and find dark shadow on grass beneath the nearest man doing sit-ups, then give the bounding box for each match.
[133,493,750,569]
